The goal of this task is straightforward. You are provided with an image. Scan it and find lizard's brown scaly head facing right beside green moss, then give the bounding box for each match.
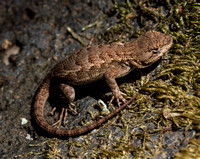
[135,31,173,68]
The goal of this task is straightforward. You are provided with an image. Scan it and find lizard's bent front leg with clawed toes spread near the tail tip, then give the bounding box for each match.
[104,66,131,106]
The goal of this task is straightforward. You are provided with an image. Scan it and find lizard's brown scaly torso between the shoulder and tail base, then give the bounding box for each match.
[51,43,130,85]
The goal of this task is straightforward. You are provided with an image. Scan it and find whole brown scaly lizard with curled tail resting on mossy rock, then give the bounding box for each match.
[33,31,173,137]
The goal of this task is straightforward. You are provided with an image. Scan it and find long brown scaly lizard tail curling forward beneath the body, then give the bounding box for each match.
[33,78,137,137]
